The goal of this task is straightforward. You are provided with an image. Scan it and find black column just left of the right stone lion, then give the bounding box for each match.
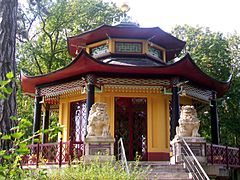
[170,81,180,140]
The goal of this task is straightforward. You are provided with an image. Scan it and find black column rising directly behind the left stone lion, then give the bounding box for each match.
[86,75,95,120]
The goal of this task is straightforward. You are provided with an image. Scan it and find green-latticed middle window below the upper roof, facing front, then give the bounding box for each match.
[115,42,142,53]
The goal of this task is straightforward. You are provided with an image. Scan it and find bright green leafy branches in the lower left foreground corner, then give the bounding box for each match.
[0,118,62,179]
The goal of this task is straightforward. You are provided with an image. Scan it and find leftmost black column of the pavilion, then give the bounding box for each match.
[32,95,42,143]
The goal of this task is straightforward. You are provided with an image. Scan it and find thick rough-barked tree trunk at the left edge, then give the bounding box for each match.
[0,0,18,149]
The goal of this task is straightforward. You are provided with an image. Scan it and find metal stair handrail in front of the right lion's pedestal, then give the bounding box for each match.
[181,139,209,180]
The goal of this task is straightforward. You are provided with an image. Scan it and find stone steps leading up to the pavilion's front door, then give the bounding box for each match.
[132,161,192,180]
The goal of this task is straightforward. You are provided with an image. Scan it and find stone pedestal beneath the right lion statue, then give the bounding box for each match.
[170,137,207,164]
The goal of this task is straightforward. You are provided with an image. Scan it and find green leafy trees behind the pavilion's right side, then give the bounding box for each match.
[173,25,240,146]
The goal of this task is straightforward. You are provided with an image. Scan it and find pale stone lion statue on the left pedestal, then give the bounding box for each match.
[87,102,110,136]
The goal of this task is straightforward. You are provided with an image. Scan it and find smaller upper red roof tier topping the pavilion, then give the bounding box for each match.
[67,25,186,60]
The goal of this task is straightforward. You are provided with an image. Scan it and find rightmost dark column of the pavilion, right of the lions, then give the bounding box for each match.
[210,91,220,144]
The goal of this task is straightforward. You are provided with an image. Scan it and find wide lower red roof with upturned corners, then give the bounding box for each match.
[21,50,230,96]
